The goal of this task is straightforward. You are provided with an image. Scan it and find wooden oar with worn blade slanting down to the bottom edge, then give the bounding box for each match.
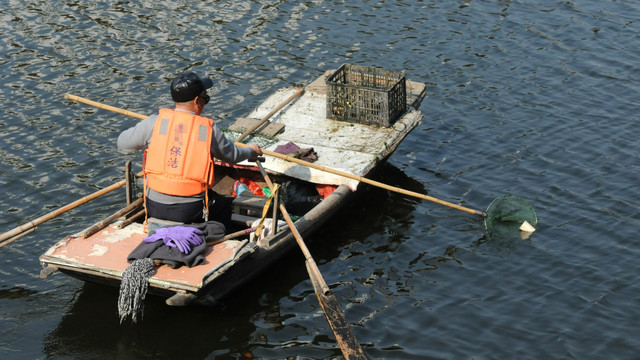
[256,161,367,359]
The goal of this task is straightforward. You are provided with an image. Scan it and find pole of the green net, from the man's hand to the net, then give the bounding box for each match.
[236,142,487,217]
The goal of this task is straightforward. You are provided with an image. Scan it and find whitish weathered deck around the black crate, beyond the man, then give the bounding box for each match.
[229,70,426,190]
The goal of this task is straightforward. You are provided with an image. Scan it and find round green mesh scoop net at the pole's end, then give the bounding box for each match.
[484,194,538,238]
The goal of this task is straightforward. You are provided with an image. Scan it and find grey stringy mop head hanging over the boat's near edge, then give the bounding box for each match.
[118,258,155,324]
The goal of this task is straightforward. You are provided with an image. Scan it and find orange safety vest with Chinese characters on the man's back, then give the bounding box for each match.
[143,109,214,196]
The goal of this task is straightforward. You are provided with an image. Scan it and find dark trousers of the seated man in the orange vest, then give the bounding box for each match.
[147,190,233,228]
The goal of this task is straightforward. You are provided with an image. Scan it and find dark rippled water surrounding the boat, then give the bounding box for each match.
[0,0,640,359]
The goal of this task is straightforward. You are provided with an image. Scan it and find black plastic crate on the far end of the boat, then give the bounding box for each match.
[325,64,407,127]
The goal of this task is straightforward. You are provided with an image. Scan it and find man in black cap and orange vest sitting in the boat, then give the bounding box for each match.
[118,72,262,227]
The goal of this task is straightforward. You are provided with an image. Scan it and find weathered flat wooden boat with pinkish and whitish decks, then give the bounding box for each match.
[40,71,425,305]
